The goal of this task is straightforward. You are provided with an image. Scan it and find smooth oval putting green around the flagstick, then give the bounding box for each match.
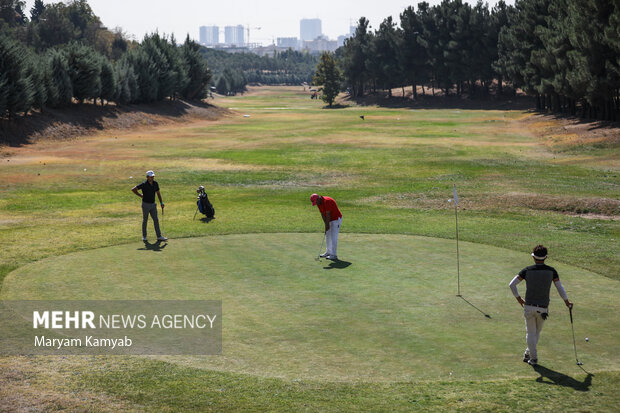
[0,233,620,381]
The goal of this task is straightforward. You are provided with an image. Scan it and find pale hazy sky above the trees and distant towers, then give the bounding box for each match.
[26,0,514,45]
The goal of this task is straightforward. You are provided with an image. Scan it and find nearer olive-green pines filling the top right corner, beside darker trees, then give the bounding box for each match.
[496,0,620,120]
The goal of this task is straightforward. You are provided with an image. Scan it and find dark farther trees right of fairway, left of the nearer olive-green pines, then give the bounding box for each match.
[336,0,508,97]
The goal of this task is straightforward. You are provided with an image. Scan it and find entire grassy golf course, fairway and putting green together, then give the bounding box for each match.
[0,86,620,412]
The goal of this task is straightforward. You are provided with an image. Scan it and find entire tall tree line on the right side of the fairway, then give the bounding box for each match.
[335,0,620,120]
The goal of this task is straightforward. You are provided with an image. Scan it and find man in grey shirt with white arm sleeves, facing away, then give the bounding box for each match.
[510,245,573,366]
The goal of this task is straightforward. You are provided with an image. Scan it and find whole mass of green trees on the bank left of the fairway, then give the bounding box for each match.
[0,0,212,118]
